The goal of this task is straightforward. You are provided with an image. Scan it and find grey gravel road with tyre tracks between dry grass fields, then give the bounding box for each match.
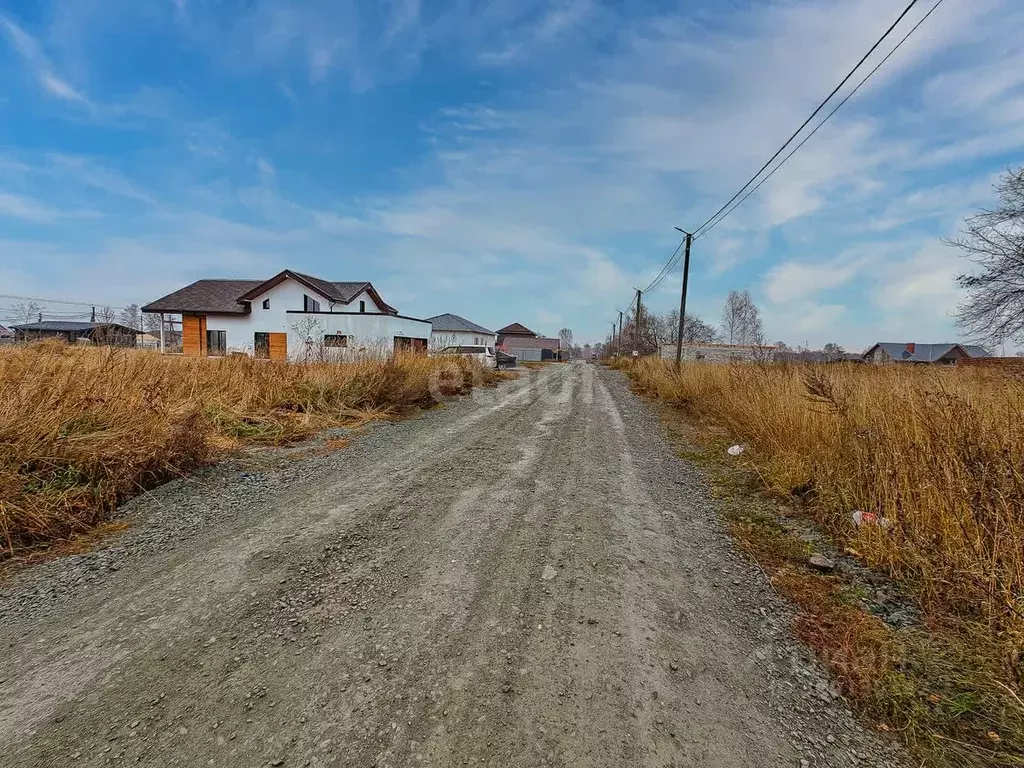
[0,364,902,768]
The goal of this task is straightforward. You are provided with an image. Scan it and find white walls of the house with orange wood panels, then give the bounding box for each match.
[201,280,430,358]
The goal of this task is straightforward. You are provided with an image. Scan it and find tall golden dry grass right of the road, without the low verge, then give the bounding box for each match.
[622,358,1024,765]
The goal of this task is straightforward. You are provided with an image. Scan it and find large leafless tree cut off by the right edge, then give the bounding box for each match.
[947,167,1024,344]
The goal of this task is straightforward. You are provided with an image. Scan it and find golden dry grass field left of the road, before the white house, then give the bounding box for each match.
[0,342,509,561]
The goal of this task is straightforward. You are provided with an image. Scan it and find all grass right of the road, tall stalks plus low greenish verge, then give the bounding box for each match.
[614,358,1024,766]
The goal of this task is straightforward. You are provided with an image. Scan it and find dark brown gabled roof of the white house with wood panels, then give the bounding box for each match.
[142,269,398,314]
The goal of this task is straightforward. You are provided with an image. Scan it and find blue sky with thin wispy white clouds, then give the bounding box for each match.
[0,0,1024,350]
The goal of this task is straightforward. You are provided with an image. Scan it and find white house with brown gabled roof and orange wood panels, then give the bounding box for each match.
[142,269,430,359]
